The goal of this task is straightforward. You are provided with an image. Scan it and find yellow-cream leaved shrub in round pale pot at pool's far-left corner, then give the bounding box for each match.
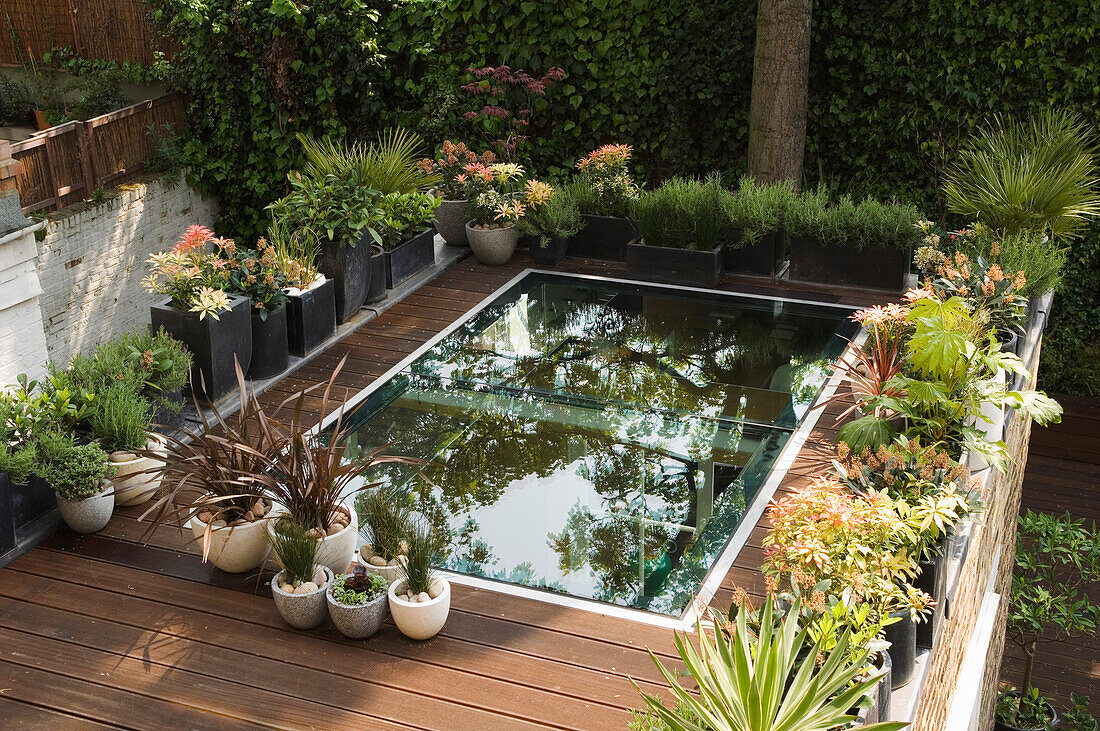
[466,163,526,266]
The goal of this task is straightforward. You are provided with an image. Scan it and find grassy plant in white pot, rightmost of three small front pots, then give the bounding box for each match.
[389,518,451,640]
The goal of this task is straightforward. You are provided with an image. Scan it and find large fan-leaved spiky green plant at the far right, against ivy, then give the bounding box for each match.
[944,109,1100,239]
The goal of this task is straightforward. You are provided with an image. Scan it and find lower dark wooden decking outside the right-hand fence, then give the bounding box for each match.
[1001,397,1100,718]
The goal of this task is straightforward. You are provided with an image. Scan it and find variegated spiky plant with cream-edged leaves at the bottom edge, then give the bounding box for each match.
[635,602,908,731]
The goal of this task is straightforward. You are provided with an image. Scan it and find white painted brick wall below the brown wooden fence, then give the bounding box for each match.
[37,174,218,363]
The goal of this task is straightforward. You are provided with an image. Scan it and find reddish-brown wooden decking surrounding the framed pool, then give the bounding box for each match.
[0,256,879,729]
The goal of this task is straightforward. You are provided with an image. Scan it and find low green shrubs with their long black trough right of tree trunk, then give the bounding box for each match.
[783,189,922,291]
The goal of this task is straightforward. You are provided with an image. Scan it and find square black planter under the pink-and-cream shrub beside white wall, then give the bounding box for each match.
[150,297,252,403]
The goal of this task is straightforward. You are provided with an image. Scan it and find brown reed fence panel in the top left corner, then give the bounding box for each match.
[0,0,172,65]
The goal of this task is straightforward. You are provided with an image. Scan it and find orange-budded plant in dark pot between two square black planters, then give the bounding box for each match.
[216,239,290,379]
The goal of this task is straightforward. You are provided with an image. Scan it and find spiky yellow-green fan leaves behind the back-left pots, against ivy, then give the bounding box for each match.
[298,128,440,195]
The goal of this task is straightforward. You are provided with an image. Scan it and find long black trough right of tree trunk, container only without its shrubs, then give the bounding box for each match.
[790,236,911,291]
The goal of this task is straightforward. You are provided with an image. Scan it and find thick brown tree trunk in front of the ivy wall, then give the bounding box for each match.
[748,0,814,188]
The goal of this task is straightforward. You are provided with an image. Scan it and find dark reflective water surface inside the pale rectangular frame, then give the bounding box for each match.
[334,272,856,616]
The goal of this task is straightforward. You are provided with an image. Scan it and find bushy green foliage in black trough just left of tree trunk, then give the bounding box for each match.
[634,175,733,252]
